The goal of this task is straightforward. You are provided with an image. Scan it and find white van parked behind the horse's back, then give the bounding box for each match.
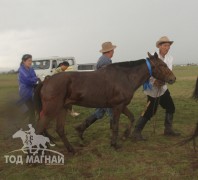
[32,57,77,81]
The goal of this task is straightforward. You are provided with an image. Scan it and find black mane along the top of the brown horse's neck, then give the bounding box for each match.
[109,59,145,68]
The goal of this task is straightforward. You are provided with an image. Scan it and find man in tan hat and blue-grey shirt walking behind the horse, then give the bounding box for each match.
[75,42,116,139]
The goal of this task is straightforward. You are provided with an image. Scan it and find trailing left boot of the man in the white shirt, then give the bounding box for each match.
[132,116,148,141]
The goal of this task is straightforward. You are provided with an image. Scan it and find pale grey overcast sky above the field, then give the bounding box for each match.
[0,0,198,68]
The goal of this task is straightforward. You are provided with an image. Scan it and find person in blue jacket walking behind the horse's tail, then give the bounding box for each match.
[18,54,38,125]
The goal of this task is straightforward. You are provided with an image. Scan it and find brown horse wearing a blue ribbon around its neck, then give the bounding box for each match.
[35,53,176,152]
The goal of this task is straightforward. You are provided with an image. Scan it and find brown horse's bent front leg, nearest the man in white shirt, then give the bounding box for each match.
[122,107,135,139]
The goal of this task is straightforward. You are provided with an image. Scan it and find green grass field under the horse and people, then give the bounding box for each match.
[0,66,198,180]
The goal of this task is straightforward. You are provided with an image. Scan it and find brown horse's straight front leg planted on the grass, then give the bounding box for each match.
[111,105,123,149]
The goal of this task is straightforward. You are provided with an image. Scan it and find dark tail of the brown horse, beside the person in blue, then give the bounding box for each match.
[33,82,43,115]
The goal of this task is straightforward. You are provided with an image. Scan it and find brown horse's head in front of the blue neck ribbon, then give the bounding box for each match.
[148,53,176,84]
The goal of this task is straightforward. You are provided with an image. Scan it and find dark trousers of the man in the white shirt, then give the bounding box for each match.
[142,89,175,120]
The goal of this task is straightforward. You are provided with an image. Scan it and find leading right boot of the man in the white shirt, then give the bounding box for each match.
[164,113,180,136]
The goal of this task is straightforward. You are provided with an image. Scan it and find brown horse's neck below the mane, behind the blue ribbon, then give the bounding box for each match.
[129,63,150,90]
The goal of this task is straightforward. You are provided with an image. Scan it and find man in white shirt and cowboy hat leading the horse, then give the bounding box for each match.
[132,36,180,140]
